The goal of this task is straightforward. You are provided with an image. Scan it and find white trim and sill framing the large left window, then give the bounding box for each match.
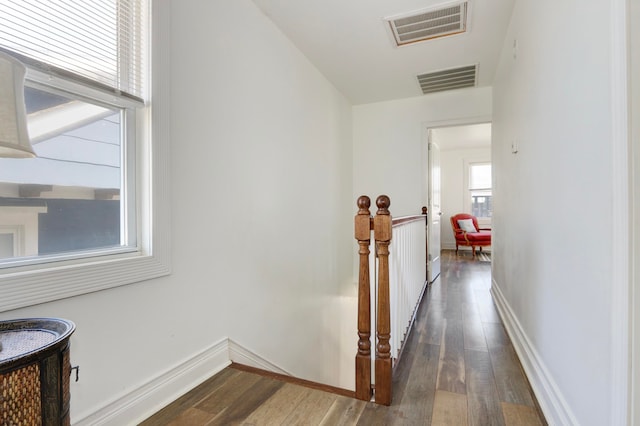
[0,0,171,312]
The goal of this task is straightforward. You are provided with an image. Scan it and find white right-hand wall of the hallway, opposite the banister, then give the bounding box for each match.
[492,0,624,426]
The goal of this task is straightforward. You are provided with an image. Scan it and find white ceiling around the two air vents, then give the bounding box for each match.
[253,0,514,105]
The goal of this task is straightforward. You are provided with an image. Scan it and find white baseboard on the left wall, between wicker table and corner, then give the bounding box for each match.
[71,339,231,426]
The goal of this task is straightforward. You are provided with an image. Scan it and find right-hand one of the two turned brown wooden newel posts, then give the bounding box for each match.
[373,195,392,405]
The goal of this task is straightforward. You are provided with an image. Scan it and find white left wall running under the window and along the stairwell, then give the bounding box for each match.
[0,0,357,424]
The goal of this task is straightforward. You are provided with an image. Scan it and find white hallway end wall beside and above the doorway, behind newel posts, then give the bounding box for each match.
[353,87,491,216]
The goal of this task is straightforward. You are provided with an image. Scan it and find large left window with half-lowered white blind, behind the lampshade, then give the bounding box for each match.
[0,0,147,267]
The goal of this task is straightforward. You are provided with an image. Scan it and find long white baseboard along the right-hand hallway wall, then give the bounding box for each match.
[491,280,578,426]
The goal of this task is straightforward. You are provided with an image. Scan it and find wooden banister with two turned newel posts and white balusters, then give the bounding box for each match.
[354,201,426,405]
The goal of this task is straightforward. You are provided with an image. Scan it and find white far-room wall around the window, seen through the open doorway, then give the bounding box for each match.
[436,146,491,250]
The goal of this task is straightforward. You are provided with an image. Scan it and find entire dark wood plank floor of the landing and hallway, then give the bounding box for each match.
[142,251,546,426]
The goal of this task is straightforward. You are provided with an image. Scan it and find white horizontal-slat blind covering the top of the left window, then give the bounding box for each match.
[0,0,146,101]
